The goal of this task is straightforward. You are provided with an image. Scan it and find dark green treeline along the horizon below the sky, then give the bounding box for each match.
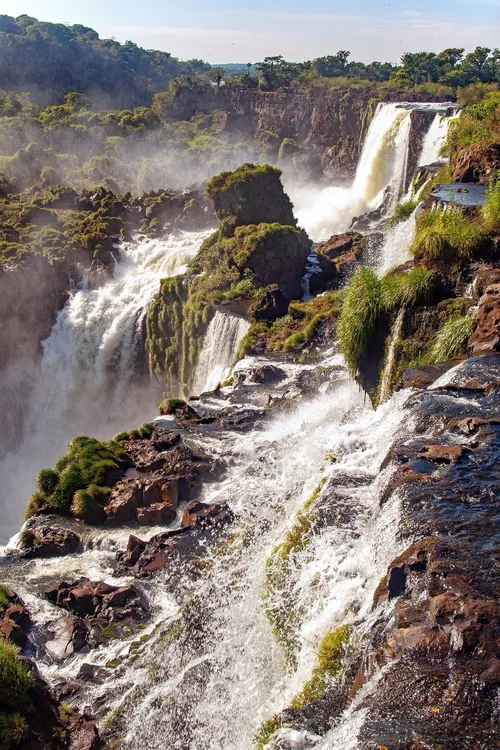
[0,15,500,109]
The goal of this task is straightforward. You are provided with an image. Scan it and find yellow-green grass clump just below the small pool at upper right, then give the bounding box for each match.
[411,208,484,261]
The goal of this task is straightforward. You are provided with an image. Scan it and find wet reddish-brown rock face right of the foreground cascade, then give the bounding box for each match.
[354,356,500,750]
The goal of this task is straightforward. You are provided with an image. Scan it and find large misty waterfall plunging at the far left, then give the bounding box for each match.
[0,232,208,541]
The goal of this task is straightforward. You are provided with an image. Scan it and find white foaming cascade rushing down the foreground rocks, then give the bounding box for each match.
[30,360,406,750]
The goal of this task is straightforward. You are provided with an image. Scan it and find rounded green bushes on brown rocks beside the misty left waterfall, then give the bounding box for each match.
[27,436,128,523]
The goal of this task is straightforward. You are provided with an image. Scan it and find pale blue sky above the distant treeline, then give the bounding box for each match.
[0,0,500,63]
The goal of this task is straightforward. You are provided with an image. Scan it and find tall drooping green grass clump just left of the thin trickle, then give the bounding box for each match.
[337,268,381,376]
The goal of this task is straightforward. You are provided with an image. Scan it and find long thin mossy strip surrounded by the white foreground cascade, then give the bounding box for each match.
[263,479,326,666]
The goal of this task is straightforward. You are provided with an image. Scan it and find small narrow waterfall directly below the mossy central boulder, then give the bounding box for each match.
[193,310,249,393]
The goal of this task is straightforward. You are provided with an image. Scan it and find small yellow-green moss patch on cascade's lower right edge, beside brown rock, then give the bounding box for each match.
[290,625,352,709]
